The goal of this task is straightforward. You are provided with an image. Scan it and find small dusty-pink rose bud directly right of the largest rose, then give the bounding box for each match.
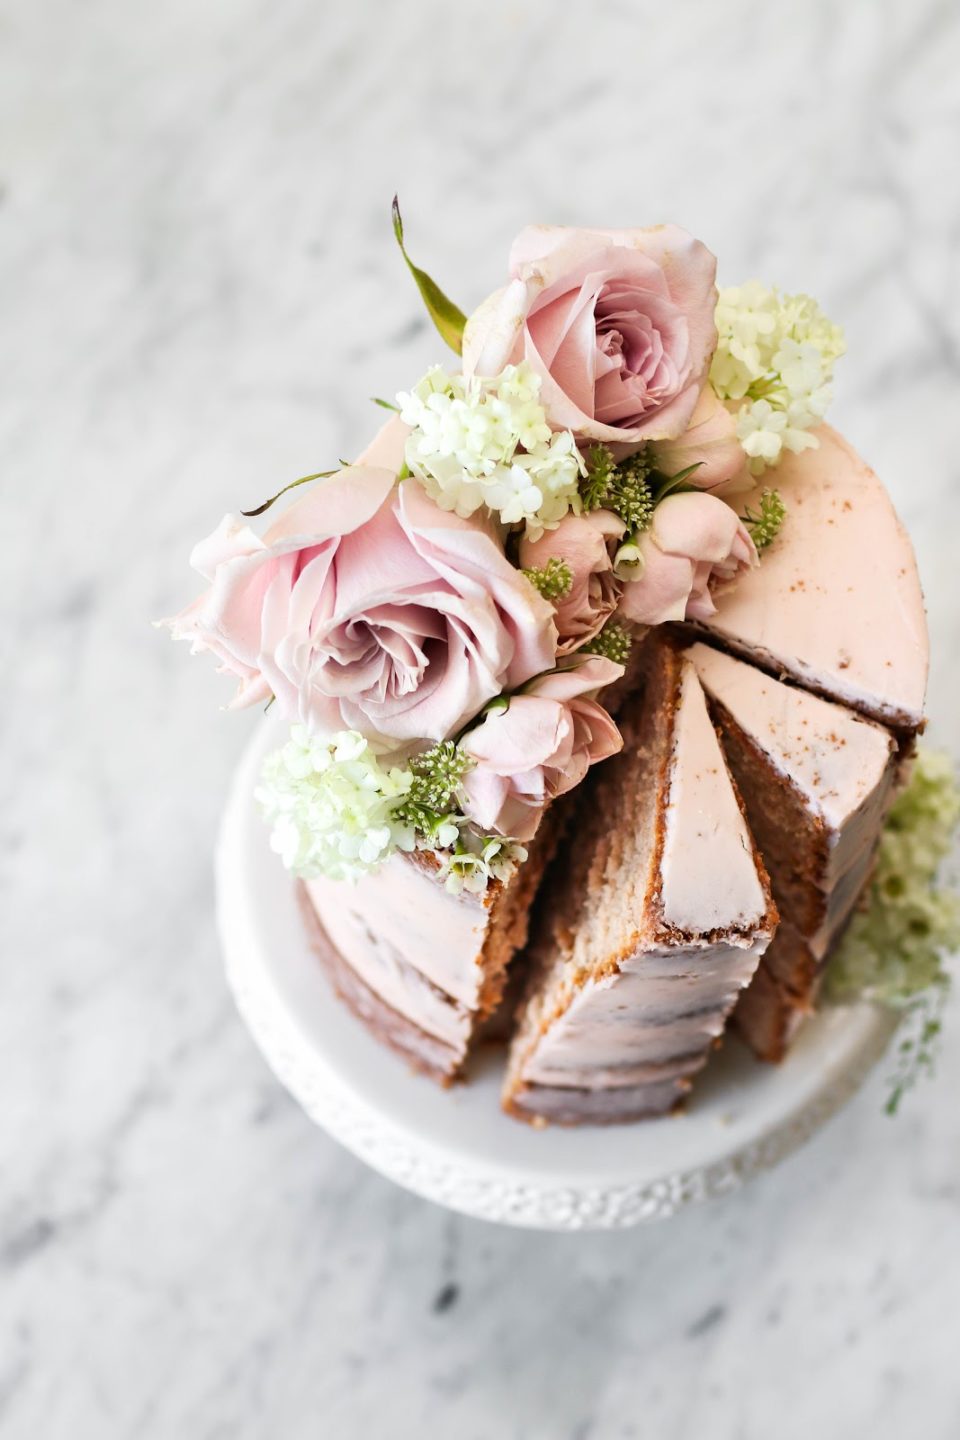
[520,510,626,655]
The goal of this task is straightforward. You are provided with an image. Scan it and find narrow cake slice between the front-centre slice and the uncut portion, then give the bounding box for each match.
[687,644,898,1061]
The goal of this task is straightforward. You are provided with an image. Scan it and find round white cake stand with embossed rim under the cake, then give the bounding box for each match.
[216,720,895,1230]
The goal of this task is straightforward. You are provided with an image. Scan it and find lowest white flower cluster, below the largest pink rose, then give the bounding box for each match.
[256,726,415,880]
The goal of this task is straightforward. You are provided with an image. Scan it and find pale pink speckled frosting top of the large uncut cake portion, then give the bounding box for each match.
[701,425,928,736]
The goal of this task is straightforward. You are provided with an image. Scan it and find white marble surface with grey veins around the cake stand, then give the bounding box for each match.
[0,0,960,1440]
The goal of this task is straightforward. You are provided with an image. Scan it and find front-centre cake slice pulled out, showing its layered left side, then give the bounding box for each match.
[504,638,776,1125]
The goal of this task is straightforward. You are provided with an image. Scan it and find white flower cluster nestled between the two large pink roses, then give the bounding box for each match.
[397,363,586,540]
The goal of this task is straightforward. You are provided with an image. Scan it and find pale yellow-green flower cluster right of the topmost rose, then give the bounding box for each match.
[710,281,846,475]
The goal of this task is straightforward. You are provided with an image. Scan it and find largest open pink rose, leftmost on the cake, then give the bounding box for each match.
[168,452,557,743]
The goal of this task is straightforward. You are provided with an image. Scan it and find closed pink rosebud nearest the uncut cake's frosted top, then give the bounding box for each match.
[620,491,759,625]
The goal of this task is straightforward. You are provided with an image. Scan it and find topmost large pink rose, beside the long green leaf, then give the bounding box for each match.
[463,225,717,456]
